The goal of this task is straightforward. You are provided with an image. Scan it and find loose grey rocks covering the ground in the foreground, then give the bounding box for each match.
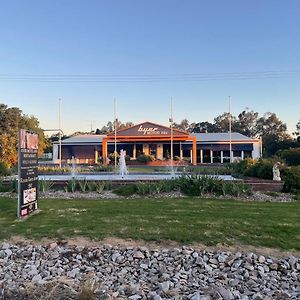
[0,243,300,300]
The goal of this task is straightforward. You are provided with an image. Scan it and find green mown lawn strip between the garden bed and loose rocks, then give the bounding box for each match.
[0,198,300,251]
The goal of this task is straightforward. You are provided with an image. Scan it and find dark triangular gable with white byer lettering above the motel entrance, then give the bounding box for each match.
[108,122,188,137]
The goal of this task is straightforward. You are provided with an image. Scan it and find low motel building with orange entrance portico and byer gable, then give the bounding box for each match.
[53,122,262,165]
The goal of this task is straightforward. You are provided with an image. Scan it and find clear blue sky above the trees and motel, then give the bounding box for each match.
[0,0,300,133]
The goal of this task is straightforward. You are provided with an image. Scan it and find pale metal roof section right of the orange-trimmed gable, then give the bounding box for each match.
[191,132,256,143]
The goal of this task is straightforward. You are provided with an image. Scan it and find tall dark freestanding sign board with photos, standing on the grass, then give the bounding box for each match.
[17,129,38,218]
